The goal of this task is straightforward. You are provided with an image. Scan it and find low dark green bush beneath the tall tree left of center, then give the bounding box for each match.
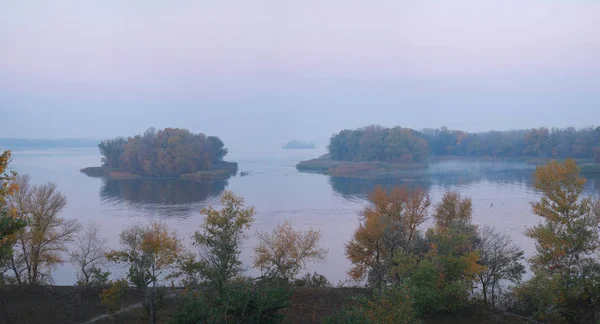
[171,279,293,324]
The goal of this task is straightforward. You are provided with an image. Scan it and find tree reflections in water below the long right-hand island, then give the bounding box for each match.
[329,170,533,198]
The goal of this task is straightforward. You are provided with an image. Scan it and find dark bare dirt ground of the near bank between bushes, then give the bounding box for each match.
[0,286,527,324]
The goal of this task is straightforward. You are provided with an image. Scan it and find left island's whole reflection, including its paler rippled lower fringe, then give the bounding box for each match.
[100,179,228,218]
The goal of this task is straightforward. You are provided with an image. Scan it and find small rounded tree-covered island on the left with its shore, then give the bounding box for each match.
[81,128,237,180]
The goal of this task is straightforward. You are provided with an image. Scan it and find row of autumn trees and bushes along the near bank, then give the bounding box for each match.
[0,147,600,323]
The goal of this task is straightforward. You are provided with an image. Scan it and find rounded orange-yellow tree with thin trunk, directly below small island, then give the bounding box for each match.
[106,223,183,323]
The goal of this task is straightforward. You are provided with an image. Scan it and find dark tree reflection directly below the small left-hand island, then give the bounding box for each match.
[100,179,227,205]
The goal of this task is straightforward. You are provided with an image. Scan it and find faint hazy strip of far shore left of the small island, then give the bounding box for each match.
[0,138,100,150]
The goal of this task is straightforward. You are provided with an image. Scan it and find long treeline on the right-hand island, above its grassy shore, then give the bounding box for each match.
[328,126,600,163]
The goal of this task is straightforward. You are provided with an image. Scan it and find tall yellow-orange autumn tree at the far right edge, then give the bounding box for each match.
[517,159,600,323]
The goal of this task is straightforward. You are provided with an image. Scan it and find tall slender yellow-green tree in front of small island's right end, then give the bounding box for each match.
[194,191,255,289]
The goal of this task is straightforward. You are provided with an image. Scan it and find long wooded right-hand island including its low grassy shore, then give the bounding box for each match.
[296,125,600,176]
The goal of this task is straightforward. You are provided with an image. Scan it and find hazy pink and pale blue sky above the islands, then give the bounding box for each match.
[0,0,600,146]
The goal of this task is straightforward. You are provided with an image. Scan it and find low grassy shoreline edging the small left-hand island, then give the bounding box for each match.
[79,162,238,181]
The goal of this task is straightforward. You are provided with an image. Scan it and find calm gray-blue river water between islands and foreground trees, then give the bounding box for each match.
[12,149,600,285]
